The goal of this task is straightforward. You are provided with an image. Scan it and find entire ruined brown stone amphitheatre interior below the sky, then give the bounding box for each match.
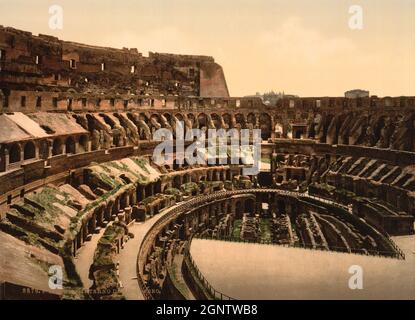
[0,27,415,300]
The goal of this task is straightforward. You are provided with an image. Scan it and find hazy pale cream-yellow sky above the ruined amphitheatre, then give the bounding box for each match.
[0,0,415,96]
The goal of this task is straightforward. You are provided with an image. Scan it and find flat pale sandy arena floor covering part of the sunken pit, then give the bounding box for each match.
[191,236,415,299]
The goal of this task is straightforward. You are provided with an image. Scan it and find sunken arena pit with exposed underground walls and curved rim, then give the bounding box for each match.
[137,189,405,299]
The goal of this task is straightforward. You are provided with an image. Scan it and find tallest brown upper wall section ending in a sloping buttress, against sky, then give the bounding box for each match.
[0,27,229,100]
